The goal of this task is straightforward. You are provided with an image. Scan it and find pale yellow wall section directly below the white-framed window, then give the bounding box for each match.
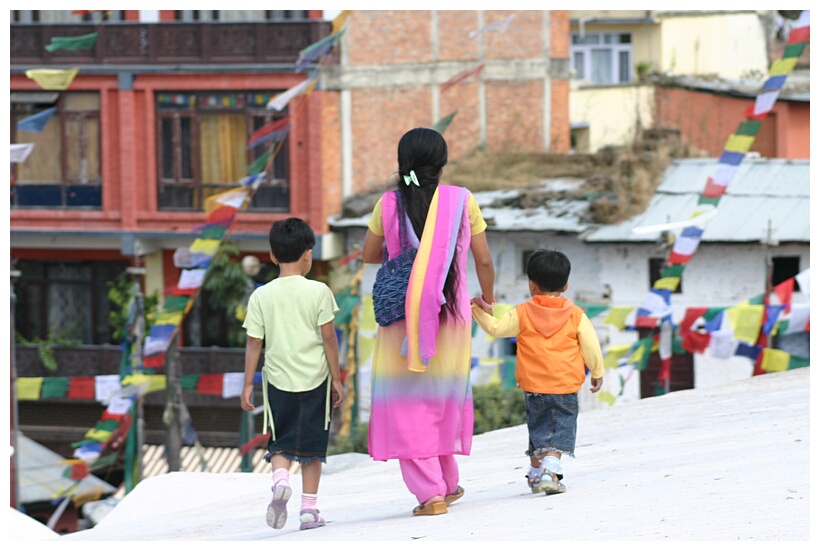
[569,84,655,153]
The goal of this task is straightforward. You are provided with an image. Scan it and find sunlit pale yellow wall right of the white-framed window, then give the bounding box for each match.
[660,13,768,79]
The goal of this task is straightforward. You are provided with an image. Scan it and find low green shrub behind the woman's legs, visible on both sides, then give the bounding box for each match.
[327,384,527,455]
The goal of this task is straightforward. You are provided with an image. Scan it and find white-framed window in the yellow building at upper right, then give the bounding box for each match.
[570,33,632,84]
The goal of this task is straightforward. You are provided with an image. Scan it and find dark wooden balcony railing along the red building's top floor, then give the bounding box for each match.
[10,21,331,66]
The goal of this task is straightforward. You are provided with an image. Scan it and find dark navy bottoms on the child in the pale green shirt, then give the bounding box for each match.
[265,379,330,463]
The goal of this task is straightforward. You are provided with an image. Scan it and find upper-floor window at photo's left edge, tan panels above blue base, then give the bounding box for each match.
[11,92,102,209]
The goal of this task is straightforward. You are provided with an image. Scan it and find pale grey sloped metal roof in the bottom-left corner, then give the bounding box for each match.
[15,434,117,504]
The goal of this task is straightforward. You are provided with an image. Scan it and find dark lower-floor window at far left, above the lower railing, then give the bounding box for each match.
[15,260,128,344]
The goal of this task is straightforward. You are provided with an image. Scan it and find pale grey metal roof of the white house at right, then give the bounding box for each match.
[586,159,810,246]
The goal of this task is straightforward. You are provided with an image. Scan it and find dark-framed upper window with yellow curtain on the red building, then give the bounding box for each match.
[156,92,290,212]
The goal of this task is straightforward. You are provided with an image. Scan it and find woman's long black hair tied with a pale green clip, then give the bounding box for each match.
[396,128,461,321]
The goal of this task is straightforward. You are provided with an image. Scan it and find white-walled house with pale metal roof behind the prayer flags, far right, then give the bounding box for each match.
[584,158,810,404]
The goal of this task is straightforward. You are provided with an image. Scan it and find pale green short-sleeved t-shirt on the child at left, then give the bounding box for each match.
[242,276,339,392]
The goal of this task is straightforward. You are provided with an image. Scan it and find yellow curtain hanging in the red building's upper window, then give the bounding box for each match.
[199,113,248,201]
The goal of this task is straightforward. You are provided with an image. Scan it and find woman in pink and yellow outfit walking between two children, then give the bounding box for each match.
[362,128,495,515]
